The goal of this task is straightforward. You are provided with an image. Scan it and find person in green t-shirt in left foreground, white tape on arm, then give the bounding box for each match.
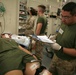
[0,35,51,75]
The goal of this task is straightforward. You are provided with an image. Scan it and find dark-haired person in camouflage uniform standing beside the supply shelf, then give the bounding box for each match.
[25,7,37,36]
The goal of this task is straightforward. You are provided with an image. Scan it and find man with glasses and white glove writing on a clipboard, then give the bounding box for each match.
[49,2,76,75]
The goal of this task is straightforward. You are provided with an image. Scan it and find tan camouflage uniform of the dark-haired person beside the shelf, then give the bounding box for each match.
[25,16,36,51]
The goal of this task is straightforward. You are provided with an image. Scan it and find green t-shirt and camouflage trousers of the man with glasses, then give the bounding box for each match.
[50,23,76,75]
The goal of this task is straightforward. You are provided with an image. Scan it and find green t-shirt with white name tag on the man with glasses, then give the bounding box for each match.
[56,24,76,60]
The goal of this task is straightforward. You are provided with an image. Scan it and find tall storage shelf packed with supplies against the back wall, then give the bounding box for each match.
[18,0,27,35]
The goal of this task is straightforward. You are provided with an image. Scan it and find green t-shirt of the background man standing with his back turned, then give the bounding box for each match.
[37,16,47,34]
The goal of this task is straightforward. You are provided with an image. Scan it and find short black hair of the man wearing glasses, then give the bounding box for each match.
[62,2,76,15]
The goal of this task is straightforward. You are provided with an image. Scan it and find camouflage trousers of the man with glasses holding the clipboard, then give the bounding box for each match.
[49,55,76,75]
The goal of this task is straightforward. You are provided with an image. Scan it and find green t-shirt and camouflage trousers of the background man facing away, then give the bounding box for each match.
[35,15,47,59]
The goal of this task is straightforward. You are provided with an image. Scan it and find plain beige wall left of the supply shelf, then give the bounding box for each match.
[0,0,18,33]
